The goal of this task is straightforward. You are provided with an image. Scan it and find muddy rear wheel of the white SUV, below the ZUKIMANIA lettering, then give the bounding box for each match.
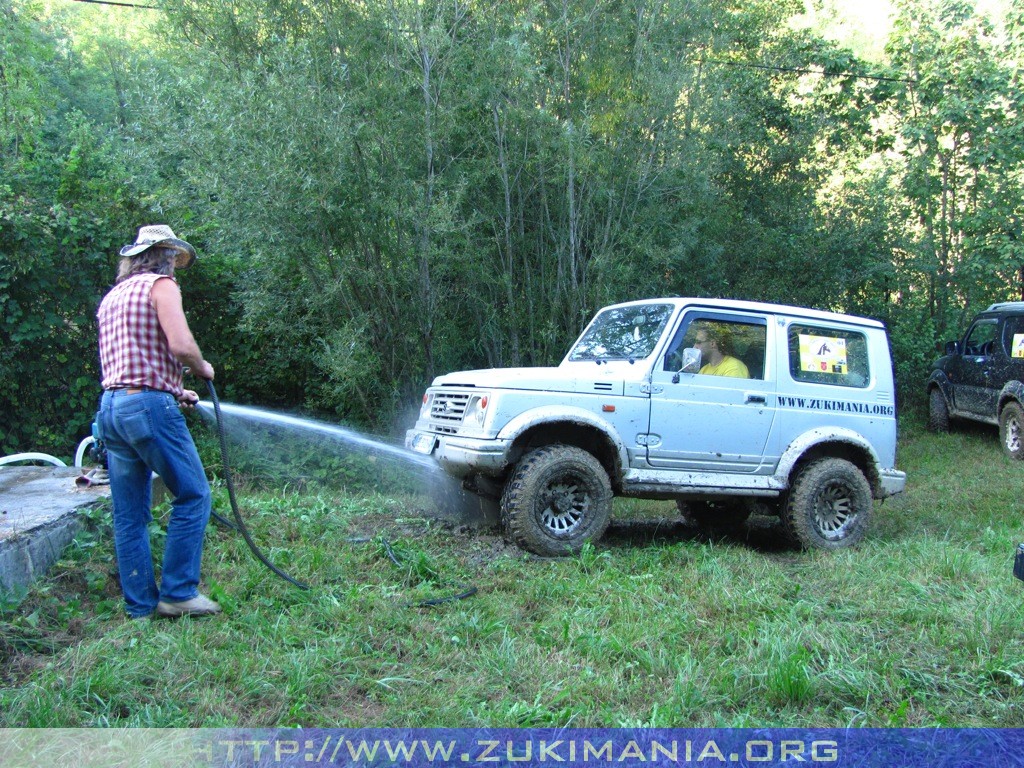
[781,459,874,550]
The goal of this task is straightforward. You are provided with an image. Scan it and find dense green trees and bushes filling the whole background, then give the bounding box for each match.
[0,0,1024,455]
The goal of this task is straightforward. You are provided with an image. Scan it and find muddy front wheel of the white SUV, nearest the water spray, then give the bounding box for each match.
[502,444,611,556]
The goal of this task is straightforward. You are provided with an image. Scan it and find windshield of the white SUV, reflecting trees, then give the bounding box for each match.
[568,304,672,360]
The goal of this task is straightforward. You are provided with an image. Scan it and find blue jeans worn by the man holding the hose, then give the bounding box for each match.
[97,389,211,617]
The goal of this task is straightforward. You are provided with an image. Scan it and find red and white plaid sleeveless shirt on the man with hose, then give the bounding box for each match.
[96,272,184,397]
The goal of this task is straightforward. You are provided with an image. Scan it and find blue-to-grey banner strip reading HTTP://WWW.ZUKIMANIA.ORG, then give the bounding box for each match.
[0,728,1024,768]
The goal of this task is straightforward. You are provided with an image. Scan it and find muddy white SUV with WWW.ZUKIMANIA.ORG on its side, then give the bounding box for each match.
[406,298,905,555]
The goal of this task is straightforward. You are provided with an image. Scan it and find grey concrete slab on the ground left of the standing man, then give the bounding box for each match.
[0,466,111,593]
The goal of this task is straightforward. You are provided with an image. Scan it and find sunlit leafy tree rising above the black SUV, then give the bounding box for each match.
[886,0,1024,337]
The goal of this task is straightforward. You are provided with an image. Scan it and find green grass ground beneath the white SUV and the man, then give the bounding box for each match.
[0,417,1024,727]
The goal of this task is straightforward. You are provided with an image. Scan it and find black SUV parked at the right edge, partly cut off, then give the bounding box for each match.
[928,301,1024,459]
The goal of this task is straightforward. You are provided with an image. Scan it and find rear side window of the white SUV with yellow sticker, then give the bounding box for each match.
[788,325,871,387]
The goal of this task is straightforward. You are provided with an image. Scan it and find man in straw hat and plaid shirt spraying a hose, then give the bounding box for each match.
[96,224,220,618]
